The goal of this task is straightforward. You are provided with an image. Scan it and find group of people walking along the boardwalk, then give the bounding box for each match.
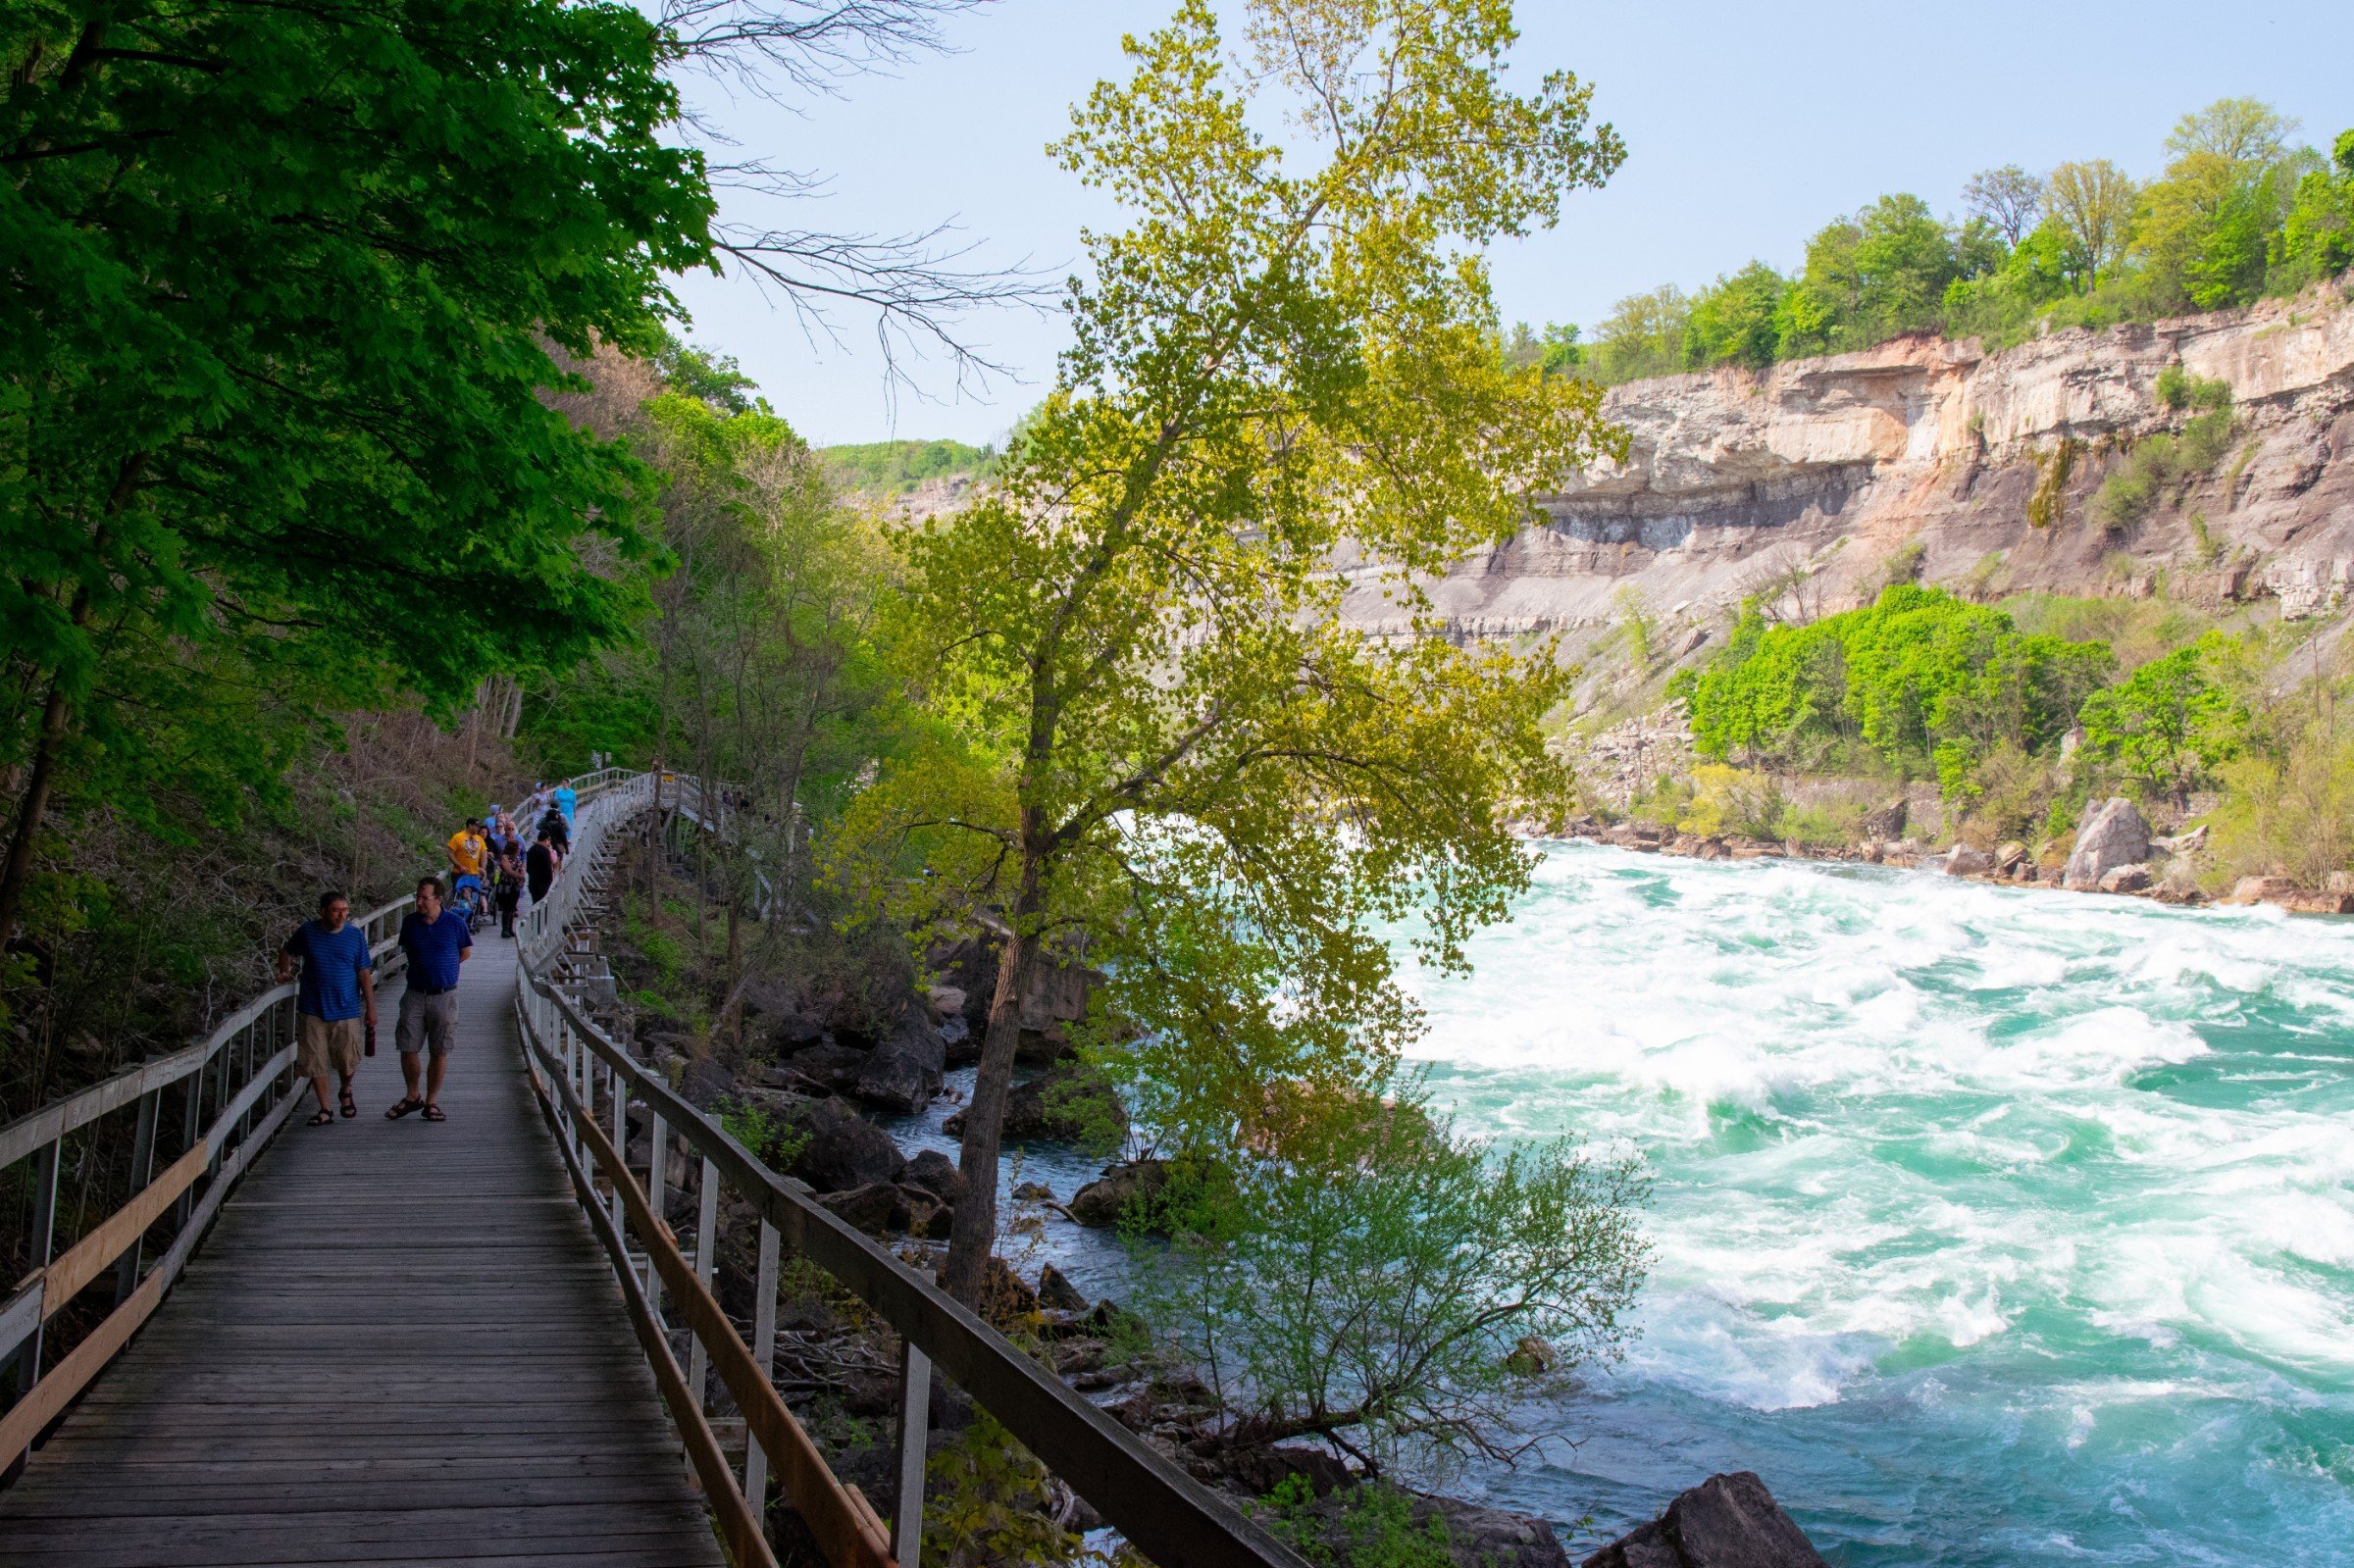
[278,784,579,1128]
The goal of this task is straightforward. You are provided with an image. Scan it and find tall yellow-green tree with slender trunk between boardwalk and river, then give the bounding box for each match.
[843,0,1622,1299]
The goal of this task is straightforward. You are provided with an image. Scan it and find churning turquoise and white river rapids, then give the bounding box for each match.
[1412,845,2354,1568]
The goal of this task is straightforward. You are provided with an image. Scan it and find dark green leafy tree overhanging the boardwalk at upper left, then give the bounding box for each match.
[0,0,711,937]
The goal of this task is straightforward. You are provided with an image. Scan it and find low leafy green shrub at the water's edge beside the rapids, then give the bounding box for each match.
[1151,1081,1648,1467]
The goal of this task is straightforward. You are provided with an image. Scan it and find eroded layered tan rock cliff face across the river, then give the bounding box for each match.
[1349,278,2354,647]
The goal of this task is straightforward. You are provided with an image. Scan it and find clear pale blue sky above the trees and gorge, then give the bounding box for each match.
[681,0,2354,445]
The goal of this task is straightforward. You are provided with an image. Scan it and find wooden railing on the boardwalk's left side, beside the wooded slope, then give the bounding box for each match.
[0,899,410,1472]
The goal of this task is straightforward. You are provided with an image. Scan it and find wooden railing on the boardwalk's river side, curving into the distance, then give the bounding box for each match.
[516,780,1305,1568]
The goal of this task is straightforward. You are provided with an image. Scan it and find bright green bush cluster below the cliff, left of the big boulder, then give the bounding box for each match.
[1688,583,2112,777]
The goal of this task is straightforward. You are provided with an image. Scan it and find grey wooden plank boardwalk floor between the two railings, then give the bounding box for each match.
[0,930,723,1568]
